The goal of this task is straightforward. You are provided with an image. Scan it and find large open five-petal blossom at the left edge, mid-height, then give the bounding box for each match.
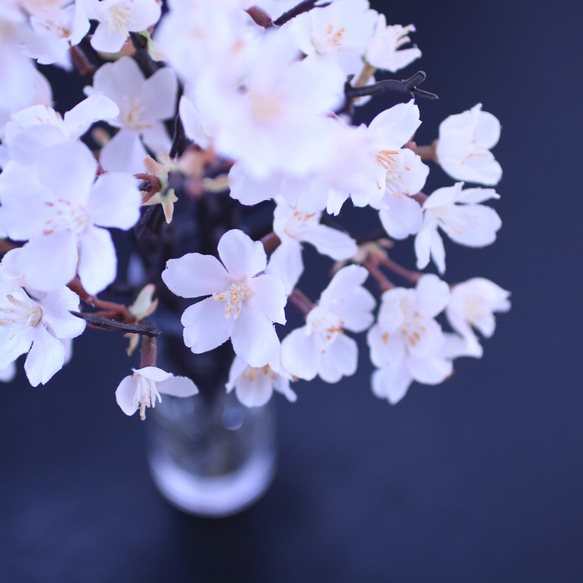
[0,142,141,294]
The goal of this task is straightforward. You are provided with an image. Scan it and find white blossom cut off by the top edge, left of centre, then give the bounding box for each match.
[84,0,161,53]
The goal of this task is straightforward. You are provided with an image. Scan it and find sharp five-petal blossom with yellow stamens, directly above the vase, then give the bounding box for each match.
[162,229,286,367]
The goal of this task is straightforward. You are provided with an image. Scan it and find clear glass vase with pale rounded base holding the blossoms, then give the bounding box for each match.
[148,330,277,517]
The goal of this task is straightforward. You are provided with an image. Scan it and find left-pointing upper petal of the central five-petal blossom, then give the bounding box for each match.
[162,253,232,298]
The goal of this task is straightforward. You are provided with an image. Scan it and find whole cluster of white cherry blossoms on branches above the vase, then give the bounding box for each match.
[0,0,510,418]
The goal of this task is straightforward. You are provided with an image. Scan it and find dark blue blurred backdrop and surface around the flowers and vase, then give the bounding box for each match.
[0,0,583,583]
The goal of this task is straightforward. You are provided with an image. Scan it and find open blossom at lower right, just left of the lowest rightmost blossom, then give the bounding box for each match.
[367,274,452,404]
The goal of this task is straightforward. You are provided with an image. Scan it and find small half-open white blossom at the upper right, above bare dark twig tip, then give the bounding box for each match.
[366,14,421,73]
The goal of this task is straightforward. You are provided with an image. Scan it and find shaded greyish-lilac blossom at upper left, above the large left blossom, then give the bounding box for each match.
[85,57,178,172]
